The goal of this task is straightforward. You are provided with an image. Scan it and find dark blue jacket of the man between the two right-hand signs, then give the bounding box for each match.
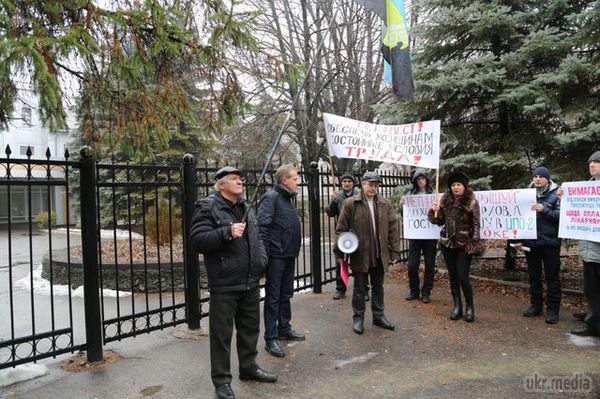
[523,180,561,248]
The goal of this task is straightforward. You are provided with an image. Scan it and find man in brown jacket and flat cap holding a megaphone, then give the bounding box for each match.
[335,172,400,334]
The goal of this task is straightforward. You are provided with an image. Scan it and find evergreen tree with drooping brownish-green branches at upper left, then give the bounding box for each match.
[0,0,255,160]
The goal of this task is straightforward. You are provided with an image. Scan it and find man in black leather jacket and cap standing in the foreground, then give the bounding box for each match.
[190,166,277,399]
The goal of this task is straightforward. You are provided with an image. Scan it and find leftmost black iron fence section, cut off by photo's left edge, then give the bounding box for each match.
[0,146,86,369]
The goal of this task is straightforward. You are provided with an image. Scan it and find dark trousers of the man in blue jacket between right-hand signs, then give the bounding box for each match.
[525,247,561,312]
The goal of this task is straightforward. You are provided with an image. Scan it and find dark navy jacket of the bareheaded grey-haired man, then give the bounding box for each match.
[257,184,302,258]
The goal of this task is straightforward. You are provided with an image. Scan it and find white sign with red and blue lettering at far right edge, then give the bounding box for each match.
[558,180,600,242]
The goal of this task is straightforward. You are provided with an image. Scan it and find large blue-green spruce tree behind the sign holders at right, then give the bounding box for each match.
[379,0,600,189]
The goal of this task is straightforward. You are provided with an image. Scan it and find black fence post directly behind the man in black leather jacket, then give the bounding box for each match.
[183,154,200,330]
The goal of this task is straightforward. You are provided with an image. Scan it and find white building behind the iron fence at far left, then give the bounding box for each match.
[0,84,76,225]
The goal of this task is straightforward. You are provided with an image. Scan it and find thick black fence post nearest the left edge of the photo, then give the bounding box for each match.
[79,147,102,362]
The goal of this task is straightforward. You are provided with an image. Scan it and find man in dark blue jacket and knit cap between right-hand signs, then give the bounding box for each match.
[516,166,561,324]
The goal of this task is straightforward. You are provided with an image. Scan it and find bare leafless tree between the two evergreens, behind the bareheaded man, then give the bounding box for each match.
[216,0,390,166]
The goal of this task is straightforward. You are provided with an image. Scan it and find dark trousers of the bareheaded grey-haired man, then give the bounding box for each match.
[264,257,296,342]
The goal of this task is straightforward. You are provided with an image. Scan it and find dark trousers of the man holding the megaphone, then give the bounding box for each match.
[352,259,384,320]
